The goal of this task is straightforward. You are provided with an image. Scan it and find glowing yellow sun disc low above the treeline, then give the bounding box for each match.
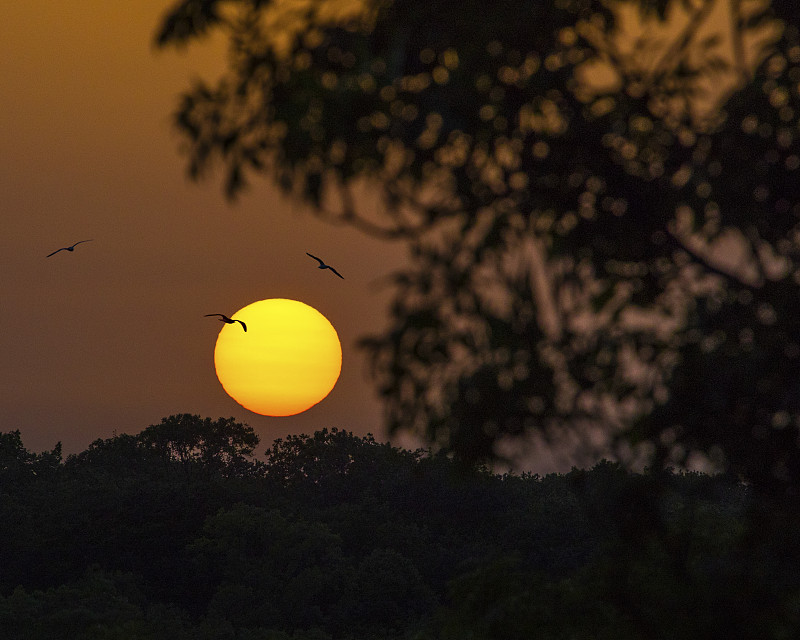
[214,298,342,416]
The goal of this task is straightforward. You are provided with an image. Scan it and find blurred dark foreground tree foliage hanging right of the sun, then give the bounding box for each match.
[157,0,800,494]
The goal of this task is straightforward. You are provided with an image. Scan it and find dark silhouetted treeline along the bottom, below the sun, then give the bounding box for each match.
[0,414,800,640]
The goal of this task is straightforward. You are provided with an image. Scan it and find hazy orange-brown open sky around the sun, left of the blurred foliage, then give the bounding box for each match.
[0,0,405,453]
